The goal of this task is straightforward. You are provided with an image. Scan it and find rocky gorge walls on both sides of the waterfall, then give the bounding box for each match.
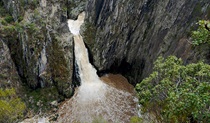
[0,0,210,111]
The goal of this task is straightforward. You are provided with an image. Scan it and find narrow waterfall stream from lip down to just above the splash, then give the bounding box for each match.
[68,12,100,84]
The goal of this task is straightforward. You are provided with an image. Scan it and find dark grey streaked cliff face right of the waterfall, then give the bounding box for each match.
[86,0,210,84]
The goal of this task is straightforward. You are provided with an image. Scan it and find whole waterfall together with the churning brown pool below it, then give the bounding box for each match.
[57,12,138,123]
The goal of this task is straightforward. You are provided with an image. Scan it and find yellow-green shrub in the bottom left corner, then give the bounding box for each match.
[0,88,26,123]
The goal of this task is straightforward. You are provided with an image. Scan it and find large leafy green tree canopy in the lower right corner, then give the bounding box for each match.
[136,56,210,123]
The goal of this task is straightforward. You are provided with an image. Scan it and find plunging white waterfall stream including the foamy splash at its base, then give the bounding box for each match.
[68,12,104,101]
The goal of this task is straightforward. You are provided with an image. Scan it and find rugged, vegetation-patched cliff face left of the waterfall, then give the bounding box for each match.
[0,0,85,97]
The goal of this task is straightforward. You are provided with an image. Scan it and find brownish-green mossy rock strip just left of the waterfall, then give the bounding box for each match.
[48,34,72,97]
